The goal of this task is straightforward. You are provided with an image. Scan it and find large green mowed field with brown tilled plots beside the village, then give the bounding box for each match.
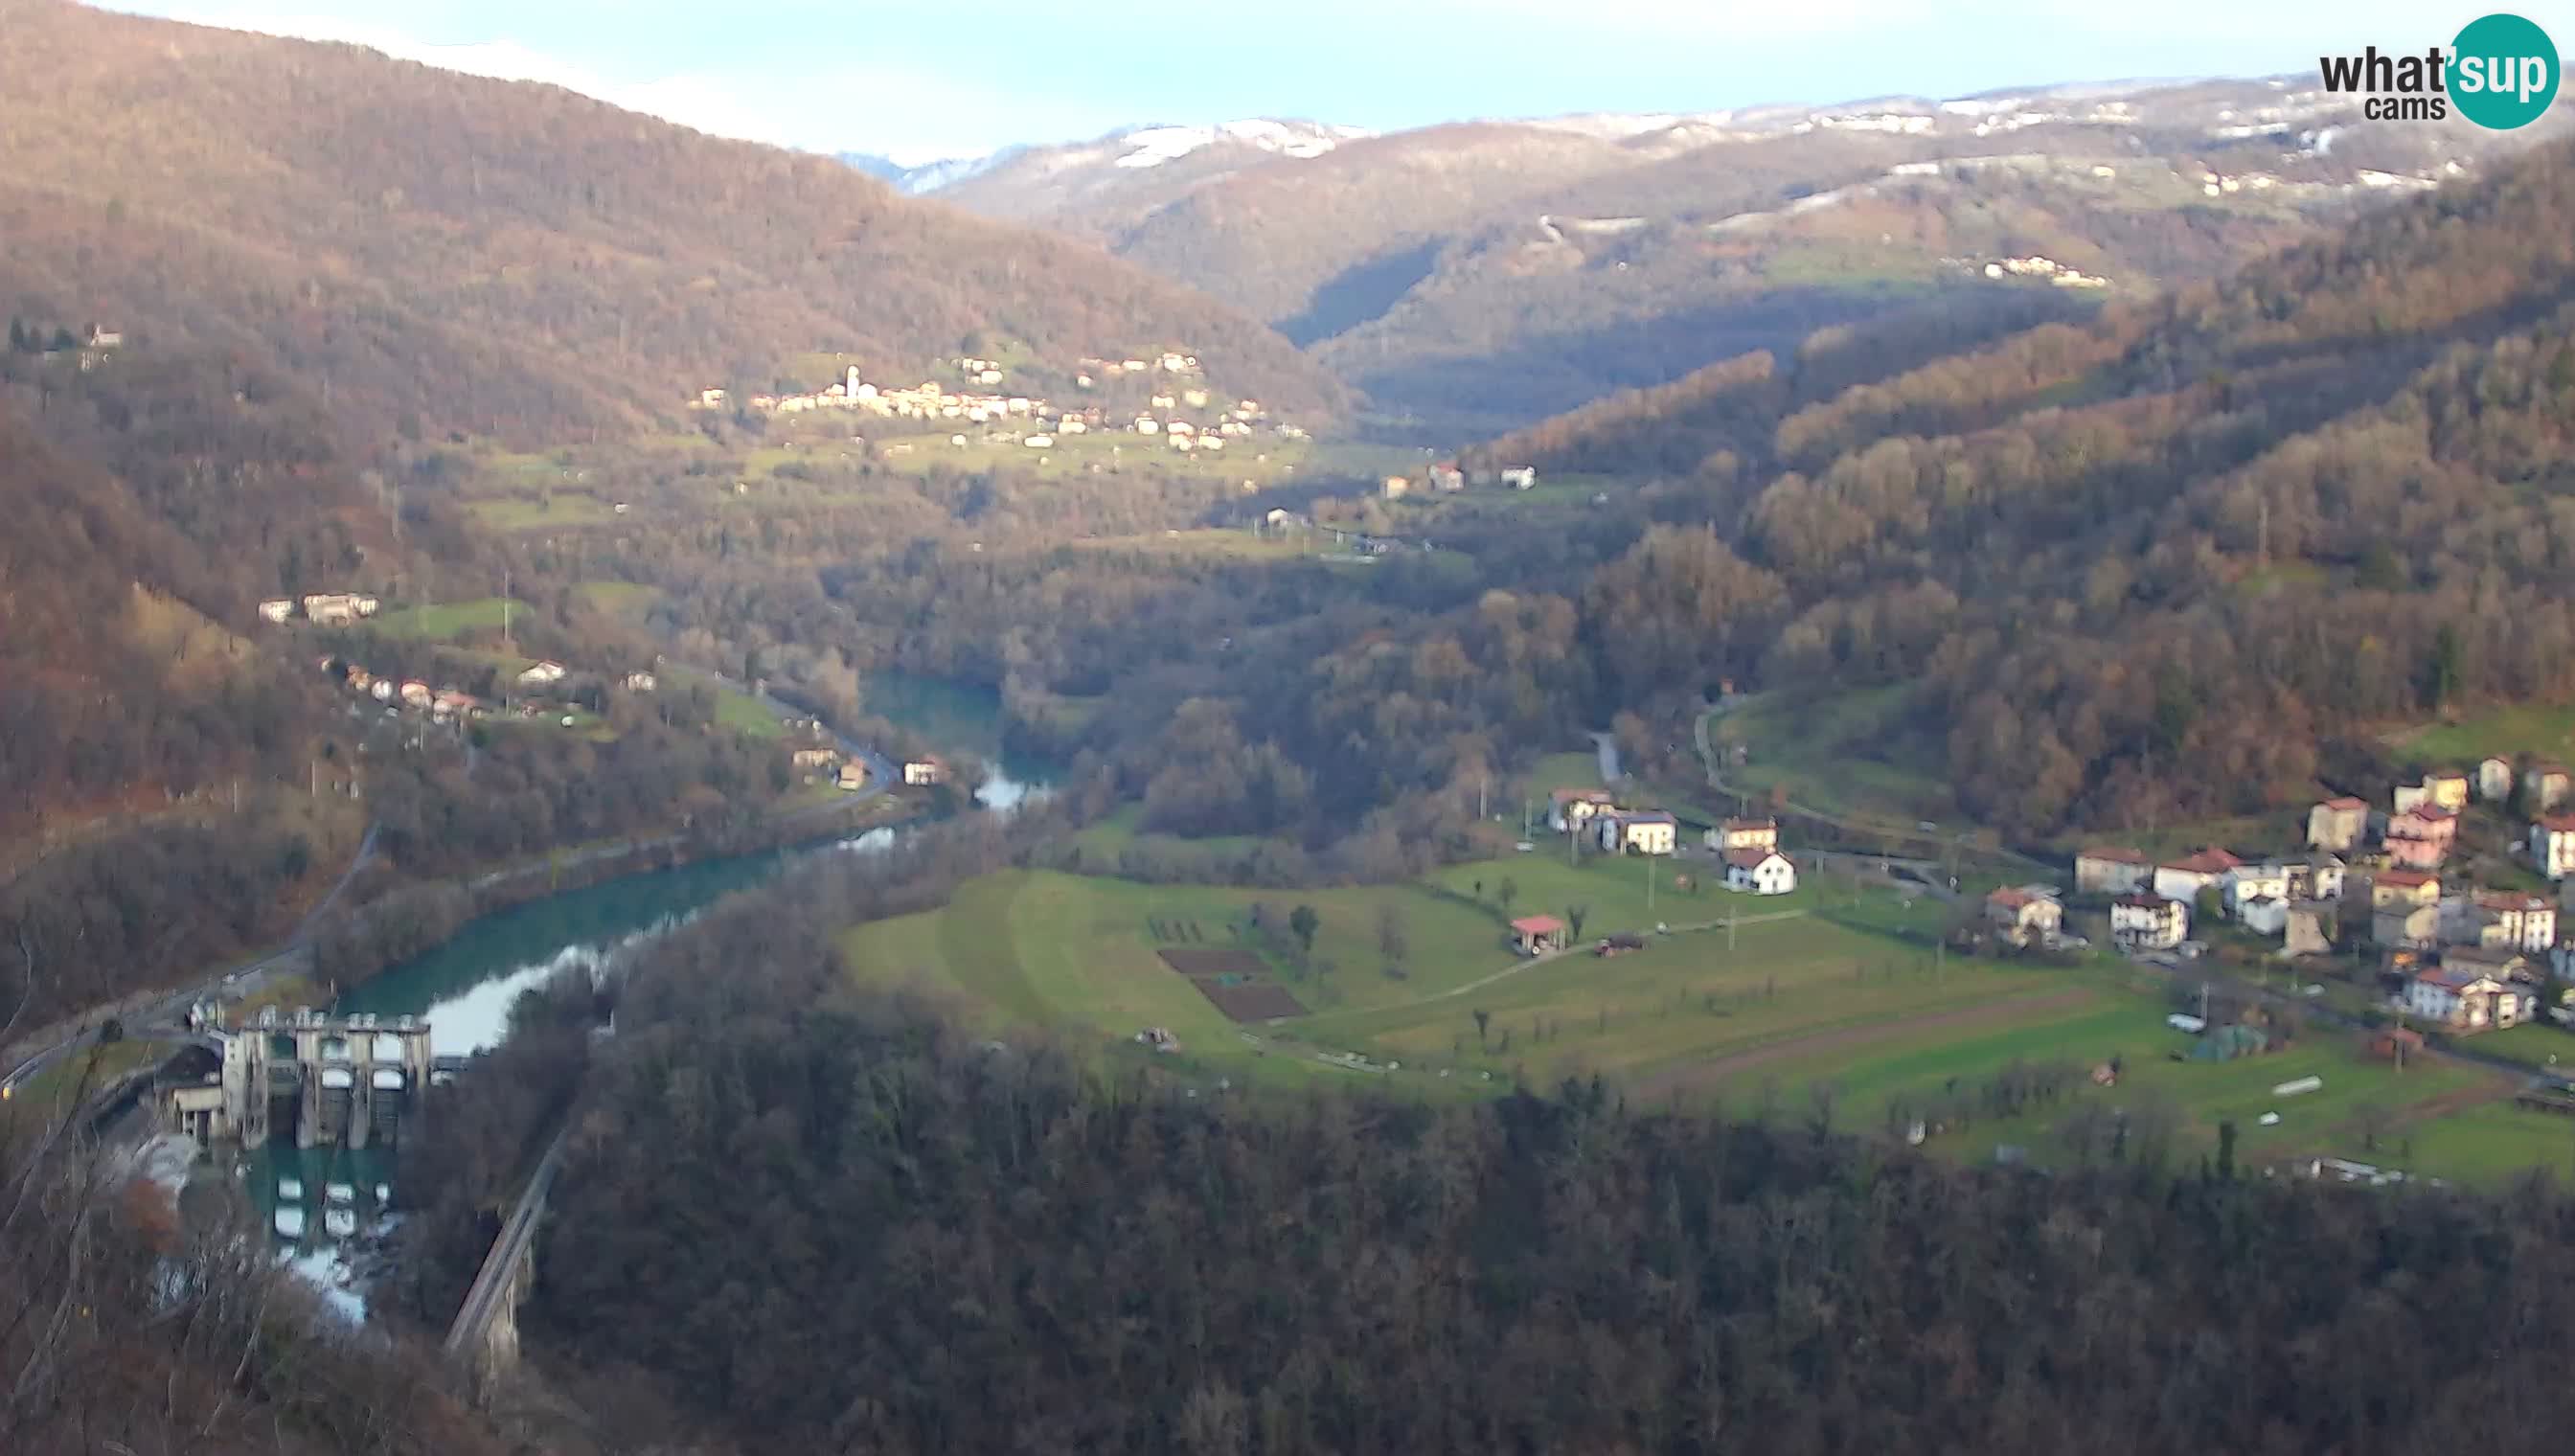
[842,855,2575,1183]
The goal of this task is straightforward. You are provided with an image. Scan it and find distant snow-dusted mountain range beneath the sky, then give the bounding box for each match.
[853,78,2564,441]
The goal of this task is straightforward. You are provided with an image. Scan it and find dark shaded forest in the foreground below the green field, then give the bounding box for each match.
[453,850,2575,1453]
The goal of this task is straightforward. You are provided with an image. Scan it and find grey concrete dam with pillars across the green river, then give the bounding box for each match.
[160,1008,441,1147]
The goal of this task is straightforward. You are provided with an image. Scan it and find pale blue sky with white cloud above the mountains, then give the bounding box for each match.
[113,0,2533,162]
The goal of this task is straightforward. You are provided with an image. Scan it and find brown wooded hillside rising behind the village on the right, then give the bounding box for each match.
[1496,145,2575,832]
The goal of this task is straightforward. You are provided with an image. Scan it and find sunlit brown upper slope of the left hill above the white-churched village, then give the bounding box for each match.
[0,0,1336,441]
